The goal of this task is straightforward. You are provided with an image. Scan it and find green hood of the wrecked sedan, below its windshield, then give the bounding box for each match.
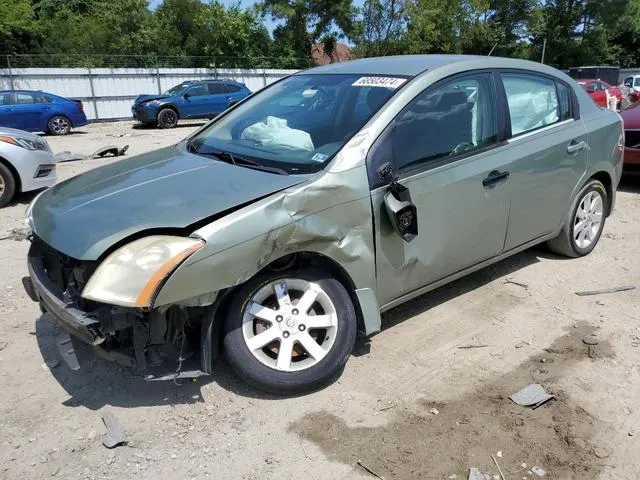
[31,146,309,260]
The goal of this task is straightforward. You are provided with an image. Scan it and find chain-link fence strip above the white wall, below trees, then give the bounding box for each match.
[0,54,314,69]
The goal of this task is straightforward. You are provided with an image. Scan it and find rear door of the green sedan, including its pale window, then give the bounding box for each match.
[501,71,588,250]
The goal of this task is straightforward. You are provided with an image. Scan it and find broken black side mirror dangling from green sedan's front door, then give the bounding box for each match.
[377,163,418,242]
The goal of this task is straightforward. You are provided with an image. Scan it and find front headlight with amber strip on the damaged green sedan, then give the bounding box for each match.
[82,235,205,308]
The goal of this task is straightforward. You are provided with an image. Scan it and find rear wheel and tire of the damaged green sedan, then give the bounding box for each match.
[547,180,609,257]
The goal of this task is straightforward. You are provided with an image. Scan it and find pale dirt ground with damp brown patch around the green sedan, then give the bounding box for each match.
[0,122,640,480]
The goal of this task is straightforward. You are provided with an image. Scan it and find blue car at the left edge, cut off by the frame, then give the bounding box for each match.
[0,90,89,135]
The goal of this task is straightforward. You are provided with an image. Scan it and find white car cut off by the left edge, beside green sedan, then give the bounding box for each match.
[0,127,56,208]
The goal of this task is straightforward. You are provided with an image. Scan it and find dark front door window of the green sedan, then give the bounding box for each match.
[383,74,498,171]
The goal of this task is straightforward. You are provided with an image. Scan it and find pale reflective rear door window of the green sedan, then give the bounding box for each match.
[502,73,560,136]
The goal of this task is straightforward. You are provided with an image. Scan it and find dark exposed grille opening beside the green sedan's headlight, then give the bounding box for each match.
[30,235,98,311]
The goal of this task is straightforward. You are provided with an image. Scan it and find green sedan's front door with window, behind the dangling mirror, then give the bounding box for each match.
[368,73,510,305]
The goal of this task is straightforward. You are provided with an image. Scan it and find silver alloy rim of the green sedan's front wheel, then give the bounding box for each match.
[242,278,338,372]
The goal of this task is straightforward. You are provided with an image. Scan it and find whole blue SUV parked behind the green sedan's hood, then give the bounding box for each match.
[131,79,251,128]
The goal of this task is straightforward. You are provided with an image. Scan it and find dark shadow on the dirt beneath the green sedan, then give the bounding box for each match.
[35,247,561,404]
